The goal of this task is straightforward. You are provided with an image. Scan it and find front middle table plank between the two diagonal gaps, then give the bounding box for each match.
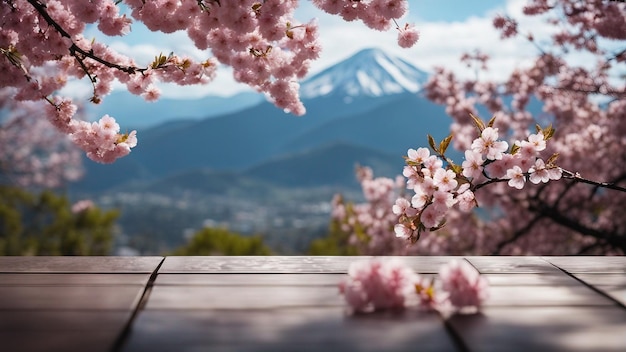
[123,307,455,352]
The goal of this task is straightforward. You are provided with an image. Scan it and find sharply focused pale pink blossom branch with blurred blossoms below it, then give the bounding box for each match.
[333,110,626,254]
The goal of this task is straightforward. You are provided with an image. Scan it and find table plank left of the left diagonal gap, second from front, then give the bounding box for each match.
[0,286,144,310]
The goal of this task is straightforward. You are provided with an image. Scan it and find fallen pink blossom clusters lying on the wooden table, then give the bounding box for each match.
[339,258,489,312]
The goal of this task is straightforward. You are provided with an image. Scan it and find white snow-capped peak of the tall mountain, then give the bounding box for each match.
[300,49,428,99]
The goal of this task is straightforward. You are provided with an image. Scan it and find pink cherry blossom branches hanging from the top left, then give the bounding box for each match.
[0,0,418,162]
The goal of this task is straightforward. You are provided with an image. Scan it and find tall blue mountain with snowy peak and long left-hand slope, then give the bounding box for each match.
[72,49,434,190]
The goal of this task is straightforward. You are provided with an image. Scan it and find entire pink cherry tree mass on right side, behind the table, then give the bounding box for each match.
[334,0,626,255]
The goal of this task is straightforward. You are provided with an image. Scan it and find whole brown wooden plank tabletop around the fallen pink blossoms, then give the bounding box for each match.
[0,256,626,352]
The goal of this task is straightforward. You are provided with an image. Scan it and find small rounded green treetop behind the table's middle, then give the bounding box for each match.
[173,227,271,255]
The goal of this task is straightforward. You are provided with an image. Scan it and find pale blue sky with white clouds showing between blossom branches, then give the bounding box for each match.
[72,0,535,99]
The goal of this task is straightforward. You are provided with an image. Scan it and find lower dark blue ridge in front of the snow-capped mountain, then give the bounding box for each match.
[118,142,404,198]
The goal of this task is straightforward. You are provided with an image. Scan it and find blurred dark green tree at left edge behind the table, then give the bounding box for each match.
[0,185,119,255]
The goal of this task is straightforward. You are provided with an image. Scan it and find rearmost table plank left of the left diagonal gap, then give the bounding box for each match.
[0,257,163,273]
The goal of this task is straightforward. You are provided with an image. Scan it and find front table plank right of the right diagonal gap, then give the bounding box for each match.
[448,307,626,352]
